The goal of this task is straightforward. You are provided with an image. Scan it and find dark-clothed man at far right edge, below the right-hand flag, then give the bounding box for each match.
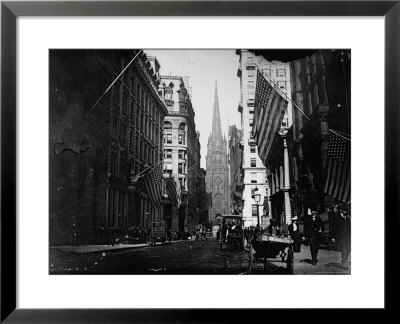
[332,204,351,266]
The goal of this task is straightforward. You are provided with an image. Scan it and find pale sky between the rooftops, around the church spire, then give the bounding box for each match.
[144,49,240,168]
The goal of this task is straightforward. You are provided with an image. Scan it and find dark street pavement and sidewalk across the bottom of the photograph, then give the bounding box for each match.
[50,238,350,274]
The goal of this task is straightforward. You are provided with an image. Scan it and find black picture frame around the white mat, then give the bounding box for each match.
[0,0,400,323]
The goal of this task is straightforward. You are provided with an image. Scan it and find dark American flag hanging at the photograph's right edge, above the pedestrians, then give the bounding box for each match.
[324,131,351,202]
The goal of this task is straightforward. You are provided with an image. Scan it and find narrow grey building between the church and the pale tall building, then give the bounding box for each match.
[228,125,243,215]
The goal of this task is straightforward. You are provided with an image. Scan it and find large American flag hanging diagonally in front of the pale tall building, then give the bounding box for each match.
[253,69,288,161]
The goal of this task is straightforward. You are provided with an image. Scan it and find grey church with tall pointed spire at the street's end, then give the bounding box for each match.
[206,82,231,224]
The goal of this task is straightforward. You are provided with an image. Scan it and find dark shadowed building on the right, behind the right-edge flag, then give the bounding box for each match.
[288,49,351,220]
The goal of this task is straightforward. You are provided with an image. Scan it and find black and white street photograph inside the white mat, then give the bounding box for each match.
[48,48,350,275]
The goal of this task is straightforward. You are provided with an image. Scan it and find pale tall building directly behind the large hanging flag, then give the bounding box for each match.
[236,49,292,227]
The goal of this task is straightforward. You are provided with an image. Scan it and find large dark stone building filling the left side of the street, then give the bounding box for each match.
[49,50,167,245]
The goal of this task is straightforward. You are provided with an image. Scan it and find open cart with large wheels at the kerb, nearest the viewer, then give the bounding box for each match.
[249,233,294,274]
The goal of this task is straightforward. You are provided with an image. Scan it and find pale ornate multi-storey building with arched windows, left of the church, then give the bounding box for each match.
[158,75,204,233]
